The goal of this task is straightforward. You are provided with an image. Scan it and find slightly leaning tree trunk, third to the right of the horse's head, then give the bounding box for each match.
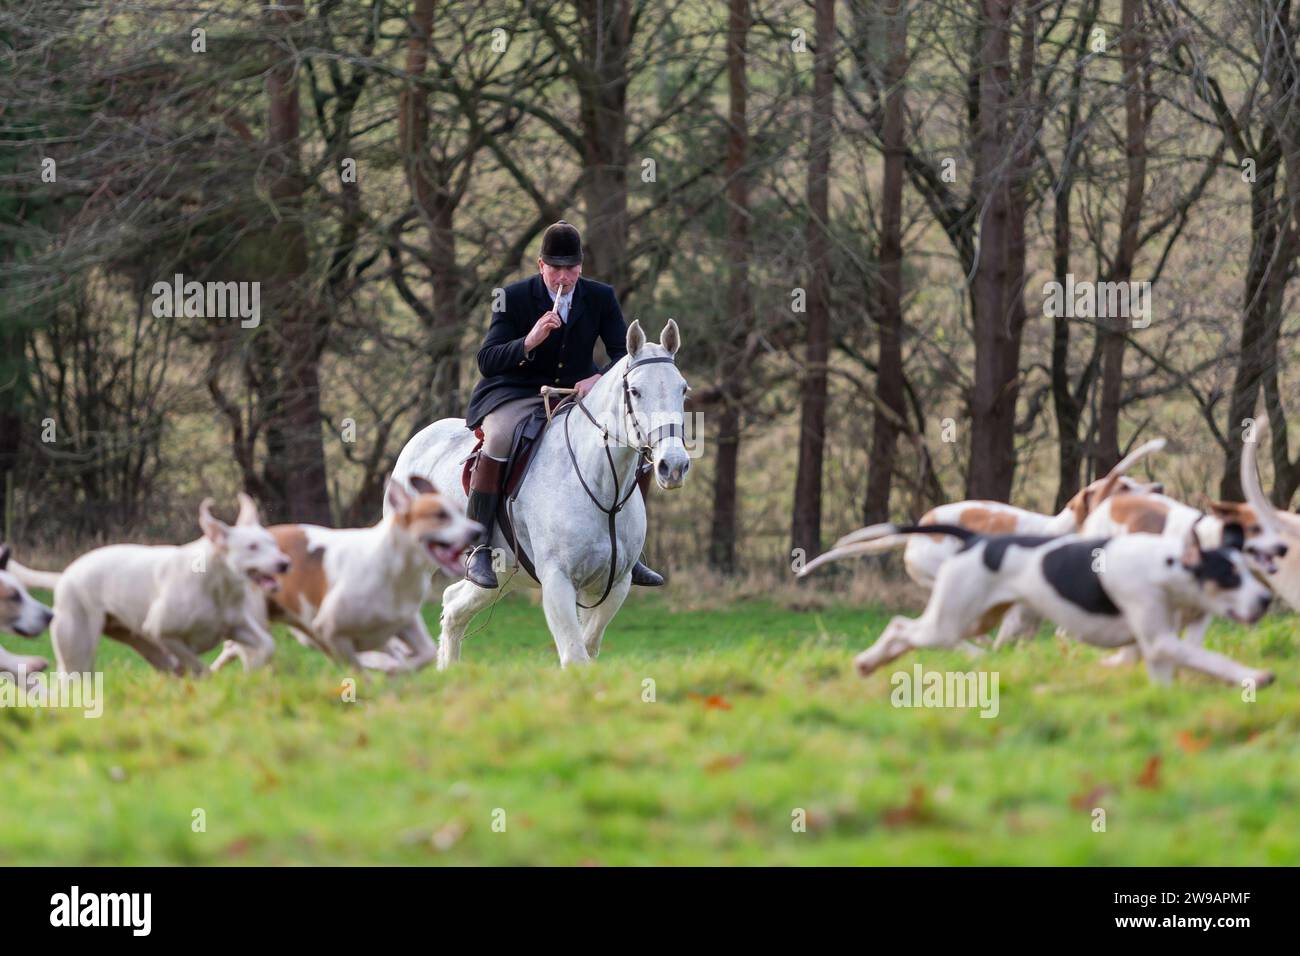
[863,0,907,524]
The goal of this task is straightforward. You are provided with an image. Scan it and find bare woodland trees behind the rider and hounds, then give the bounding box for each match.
[0,0,1300,574]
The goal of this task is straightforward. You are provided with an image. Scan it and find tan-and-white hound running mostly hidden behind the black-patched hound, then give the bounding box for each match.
[800,438,1165,646]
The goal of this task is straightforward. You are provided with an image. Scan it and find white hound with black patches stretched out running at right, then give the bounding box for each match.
[854,524,1274,687]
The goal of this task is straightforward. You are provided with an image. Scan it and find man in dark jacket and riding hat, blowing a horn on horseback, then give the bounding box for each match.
[465,220,663,588]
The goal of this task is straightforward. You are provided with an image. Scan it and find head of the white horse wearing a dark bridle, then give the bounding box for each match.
[623,319,690,489]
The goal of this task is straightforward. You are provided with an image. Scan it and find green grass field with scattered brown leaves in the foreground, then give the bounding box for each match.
[0,582,1300,865]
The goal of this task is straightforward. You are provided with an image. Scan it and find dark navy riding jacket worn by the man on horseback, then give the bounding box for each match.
[465,274,628,428]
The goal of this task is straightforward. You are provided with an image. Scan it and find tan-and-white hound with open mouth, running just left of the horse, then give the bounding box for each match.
[212,476,484,672]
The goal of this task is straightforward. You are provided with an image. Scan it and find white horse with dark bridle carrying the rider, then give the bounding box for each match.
[385,320,690,670]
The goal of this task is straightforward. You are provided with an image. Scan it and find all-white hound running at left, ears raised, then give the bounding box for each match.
[36,493,290,676]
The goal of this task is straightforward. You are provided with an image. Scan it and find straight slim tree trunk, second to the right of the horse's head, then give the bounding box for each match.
[790,0,835,557]
